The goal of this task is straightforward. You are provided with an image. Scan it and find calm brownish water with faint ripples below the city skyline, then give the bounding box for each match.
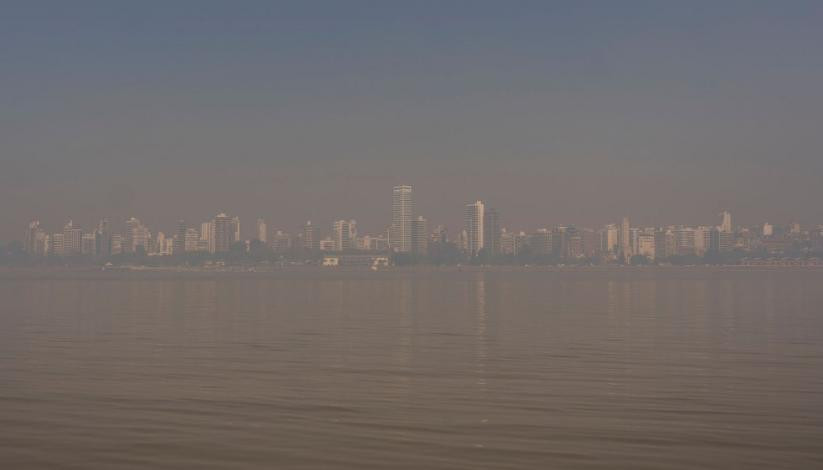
[0,271,823,469]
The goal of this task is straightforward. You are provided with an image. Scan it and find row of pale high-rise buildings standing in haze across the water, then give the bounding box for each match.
[17,185,823,263]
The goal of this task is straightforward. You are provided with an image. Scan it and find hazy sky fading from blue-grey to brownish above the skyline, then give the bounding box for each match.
[0,0,823,240]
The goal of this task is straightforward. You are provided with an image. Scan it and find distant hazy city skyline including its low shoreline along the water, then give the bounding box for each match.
[3,185,823,266]
